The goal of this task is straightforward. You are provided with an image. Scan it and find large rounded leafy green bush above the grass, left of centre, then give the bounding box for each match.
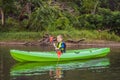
[28,2,75,31]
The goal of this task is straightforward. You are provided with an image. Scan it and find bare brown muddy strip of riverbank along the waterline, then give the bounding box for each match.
[0,40,120,47]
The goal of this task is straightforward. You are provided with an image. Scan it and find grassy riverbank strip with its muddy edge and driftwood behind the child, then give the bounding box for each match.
[0,30,120,46]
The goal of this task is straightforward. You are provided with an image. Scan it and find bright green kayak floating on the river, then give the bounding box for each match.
[10,48,110,62]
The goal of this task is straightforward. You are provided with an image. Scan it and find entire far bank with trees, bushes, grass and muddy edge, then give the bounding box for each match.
[0,0,120,45]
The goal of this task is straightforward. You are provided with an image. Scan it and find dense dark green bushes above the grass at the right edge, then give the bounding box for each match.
[77,8,120,34]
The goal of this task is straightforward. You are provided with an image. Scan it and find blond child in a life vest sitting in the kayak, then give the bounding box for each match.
[54,35,66,53]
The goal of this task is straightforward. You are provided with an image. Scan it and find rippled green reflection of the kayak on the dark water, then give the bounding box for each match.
[10,58,110,76]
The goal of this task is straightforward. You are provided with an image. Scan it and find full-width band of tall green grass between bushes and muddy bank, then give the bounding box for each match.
[0,29,120,41]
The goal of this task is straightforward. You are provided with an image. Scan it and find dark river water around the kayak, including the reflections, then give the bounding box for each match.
[0,46,120,80]
